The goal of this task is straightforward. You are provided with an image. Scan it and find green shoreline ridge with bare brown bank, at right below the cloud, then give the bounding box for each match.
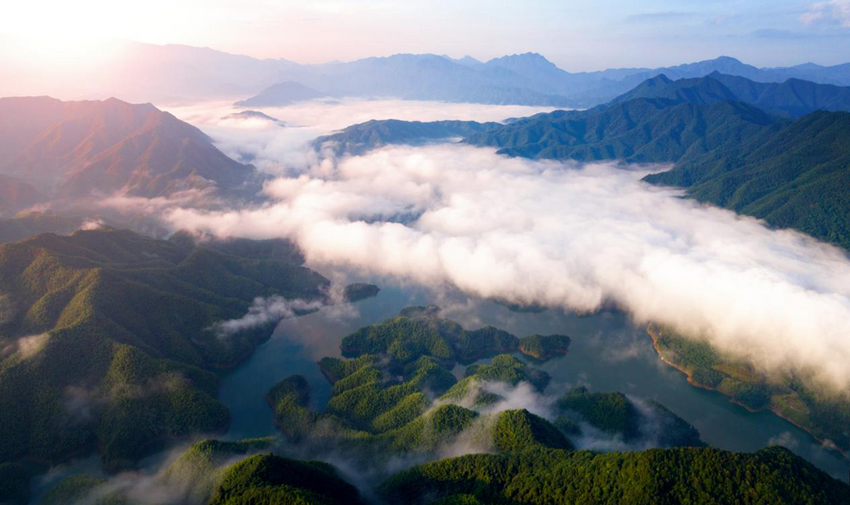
[647,325,850,454]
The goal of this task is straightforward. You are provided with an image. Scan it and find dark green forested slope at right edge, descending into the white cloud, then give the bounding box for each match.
[646,112,850,249]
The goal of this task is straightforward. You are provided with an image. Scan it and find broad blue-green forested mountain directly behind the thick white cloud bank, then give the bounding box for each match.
[465,98,777,163]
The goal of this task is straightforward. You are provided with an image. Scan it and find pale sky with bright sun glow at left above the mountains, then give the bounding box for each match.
[0,0,850,71]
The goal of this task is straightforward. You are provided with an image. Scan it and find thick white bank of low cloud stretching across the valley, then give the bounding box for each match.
[149,116,850,388]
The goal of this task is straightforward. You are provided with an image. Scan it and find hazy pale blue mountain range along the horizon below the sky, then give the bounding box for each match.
[6,42,850,107]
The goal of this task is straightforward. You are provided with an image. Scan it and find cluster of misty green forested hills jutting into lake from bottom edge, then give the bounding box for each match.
[36,307,850,505]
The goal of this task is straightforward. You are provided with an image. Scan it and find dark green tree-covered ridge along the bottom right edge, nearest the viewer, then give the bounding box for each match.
[380,447,850,505]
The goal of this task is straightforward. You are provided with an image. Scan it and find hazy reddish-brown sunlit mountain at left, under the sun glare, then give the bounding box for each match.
[0,97,259,198]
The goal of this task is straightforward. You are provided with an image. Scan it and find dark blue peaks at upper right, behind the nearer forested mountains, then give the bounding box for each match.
[613,72,850,117]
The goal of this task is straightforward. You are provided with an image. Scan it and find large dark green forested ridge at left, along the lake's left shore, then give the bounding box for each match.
[0,230,328,470]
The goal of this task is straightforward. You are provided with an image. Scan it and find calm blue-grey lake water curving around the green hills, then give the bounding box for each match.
[220,283,850,480]
